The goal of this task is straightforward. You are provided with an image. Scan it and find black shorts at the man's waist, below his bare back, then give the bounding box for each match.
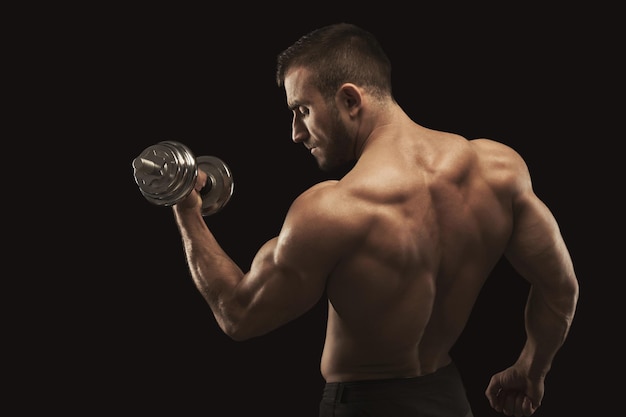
[319,363,473,417]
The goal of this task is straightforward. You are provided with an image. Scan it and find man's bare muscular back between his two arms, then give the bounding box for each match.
[321,125,512,382]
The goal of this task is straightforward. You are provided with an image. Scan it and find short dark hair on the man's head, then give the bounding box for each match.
[276,23,391,98]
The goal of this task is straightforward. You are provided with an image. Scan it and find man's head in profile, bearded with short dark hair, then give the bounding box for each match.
[276,23,391,171]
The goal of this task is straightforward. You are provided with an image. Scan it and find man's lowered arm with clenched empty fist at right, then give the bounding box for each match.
[486,154,579,416]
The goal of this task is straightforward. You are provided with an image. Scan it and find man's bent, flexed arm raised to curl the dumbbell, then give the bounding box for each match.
[173,176,342,340]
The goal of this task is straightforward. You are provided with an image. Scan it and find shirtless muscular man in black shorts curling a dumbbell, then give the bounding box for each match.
[173,24,578,417]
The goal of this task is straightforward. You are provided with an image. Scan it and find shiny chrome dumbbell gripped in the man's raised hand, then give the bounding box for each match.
[132,141,234,216]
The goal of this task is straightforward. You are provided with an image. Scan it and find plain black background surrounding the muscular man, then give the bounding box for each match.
[13,4,624,417]
